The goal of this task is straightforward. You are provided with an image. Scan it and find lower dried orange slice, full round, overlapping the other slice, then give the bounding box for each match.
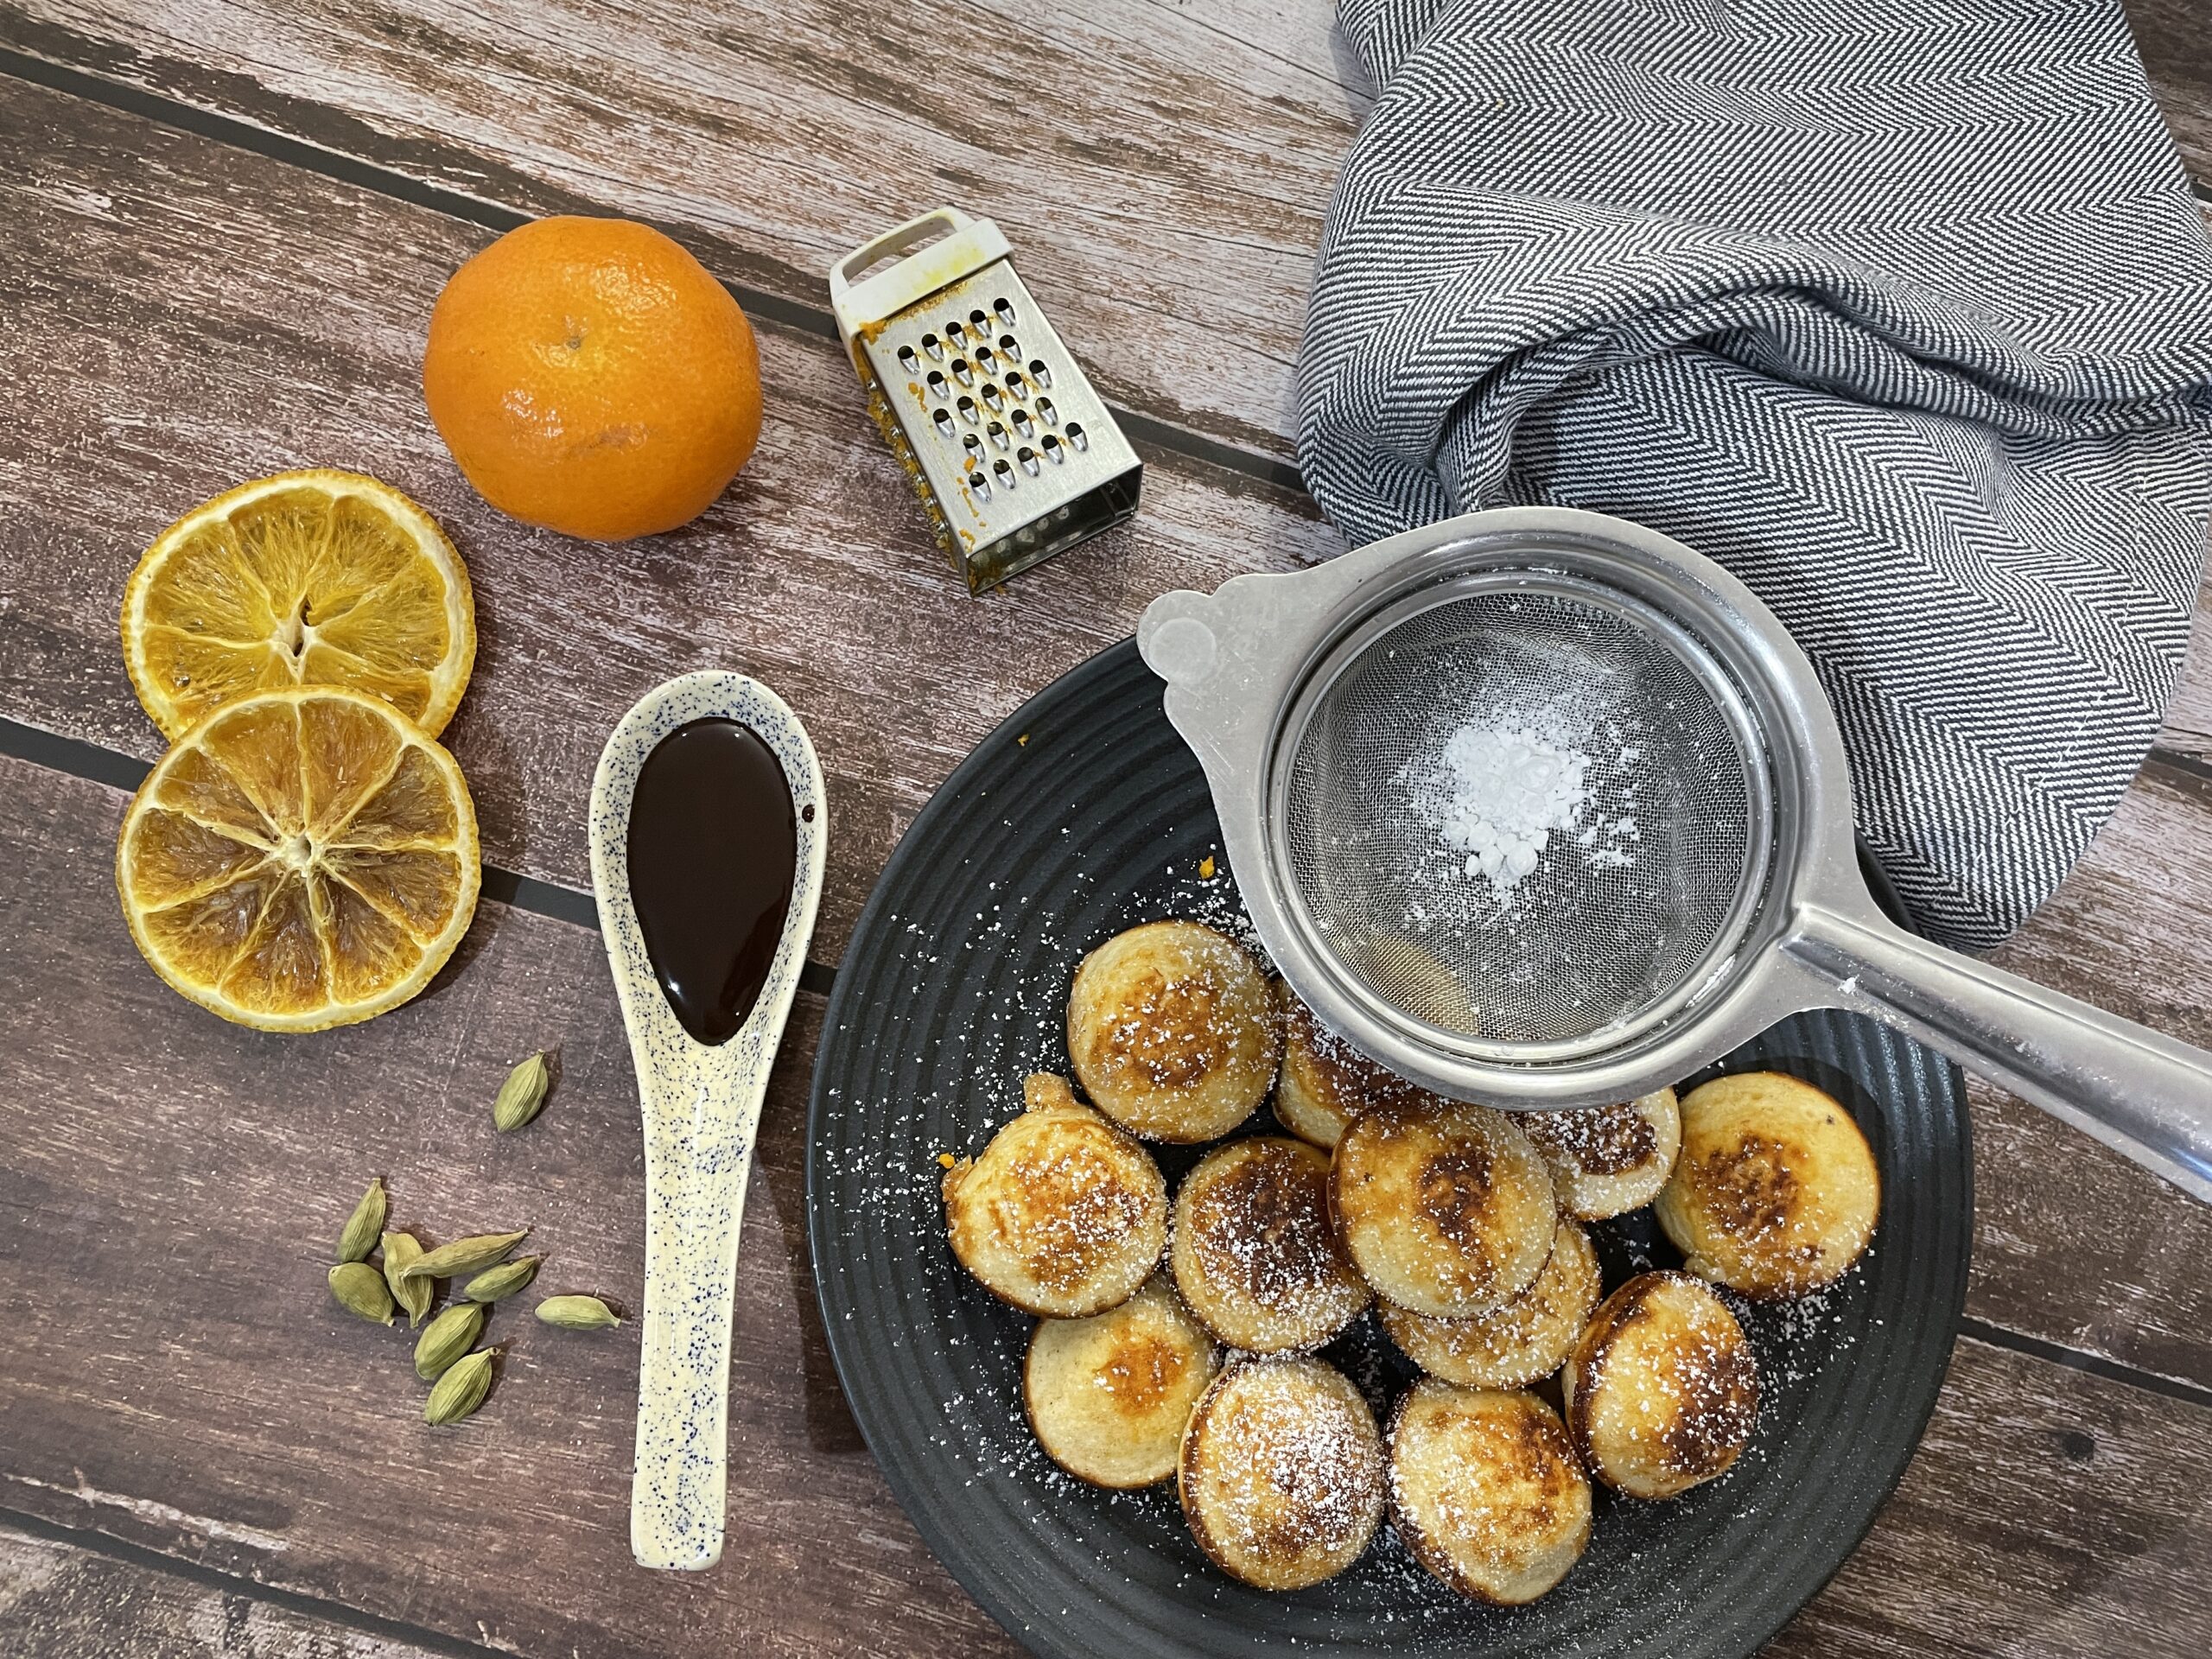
[115,686,480,1031]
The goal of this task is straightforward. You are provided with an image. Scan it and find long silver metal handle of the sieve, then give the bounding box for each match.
[1783,909,2212,1204]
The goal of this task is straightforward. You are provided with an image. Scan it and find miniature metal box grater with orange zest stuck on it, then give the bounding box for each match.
[830,208,1144,593]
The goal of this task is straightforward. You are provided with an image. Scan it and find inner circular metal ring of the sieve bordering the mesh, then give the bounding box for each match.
[1263,566,1777,1066]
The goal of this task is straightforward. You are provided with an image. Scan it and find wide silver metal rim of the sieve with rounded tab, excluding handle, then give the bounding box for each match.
[1137,506,1849,1110]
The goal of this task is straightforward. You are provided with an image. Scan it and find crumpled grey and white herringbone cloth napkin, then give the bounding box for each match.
[1299,0,2212,949]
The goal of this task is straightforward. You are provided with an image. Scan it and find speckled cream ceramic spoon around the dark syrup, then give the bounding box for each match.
[591,672,830,1568]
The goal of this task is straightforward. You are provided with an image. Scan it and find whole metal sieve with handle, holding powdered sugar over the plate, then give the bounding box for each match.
[1137,506,2212,1201]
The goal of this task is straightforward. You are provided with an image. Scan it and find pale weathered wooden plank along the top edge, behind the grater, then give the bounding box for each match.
[0,0,2212,473]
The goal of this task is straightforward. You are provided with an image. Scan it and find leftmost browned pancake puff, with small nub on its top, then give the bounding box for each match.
[944,1075,1168,1319]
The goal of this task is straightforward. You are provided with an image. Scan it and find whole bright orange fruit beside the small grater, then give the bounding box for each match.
[423,217,761,542]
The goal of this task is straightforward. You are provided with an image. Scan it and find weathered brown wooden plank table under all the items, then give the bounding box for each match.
[0,0,2212,1659]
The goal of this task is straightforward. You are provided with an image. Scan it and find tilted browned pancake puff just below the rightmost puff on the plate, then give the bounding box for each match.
[1560,1272,1758,1497]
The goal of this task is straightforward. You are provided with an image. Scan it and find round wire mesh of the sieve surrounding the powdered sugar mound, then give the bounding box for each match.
[1281,575,1772,1055]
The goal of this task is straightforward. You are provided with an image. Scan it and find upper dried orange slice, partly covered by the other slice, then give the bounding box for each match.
[124,471,475,743]
